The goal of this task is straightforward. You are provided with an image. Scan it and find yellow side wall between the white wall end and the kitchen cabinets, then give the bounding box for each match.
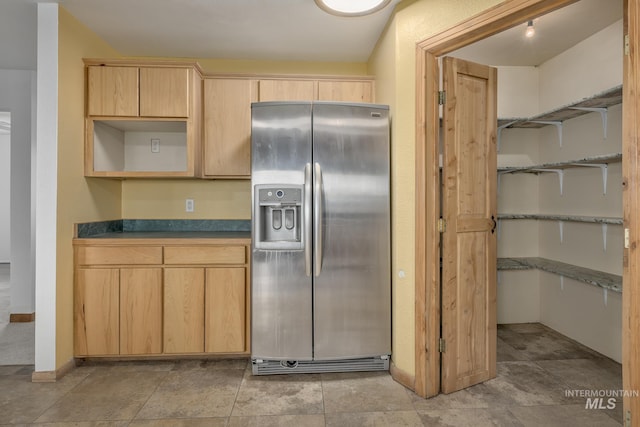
[56,7,122,368]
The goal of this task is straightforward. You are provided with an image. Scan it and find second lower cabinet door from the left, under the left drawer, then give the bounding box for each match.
[120,268,162,354]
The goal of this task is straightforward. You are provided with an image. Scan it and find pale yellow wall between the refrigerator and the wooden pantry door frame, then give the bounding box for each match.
[368,0,501,382]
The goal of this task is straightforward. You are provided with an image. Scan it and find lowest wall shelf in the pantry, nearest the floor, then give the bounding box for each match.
[498,257,622,293]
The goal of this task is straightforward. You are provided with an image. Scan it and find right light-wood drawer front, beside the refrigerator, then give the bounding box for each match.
[164,246,246,264]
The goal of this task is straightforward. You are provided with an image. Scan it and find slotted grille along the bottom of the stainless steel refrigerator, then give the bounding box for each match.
[251,355,389,375]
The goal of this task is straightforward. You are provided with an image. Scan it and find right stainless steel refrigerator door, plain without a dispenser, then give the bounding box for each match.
[313,103,391,360]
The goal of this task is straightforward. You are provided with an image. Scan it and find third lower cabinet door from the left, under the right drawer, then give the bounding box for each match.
[164,268,204,353]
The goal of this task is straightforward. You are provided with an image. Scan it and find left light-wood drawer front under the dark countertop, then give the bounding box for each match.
[77,246,162,265]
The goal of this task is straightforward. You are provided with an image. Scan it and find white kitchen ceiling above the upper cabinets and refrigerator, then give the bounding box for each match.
[59,0,400,62]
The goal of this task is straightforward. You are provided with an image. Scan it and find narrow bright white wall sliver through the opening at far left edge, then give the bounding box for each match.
[0,131,11,263]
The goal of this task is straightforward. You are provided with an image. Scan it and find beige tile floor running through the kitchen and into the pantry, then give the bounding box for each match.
[0,324,622,427]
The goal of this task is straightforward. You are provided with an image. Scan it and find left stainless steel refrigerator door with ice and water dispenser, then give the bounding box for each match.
[251,103,313,360]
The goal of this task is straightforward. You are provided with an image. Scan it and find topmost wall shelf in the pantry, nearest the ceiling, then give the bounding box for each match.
[498,86,622,128]
